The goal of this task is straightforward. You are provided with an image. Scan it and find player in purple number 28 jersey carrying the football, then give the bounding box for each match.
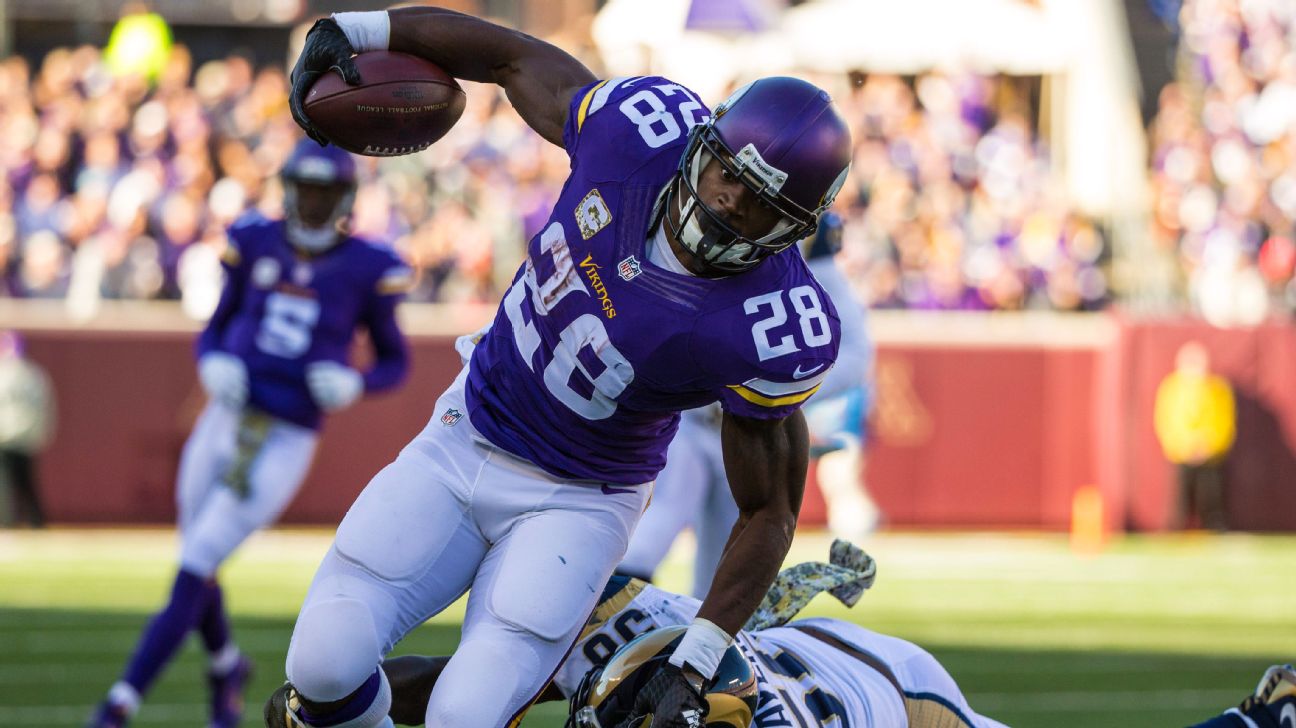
[267,8,851,728]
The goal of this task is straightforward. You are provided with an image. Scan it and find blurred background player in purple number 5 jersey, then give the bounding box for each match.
[91,140,410,728]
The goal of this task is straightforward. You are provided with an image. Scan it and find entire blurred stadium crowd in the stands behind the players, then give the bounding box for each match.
[0,0,1296,317]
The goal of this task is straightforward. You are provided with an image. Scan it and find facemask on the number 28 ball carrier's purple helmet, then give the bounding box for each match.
[665,124,819,275]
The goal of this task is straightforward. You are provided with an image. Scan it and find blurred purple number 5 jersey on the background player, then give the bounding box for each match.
[197,214,411,427]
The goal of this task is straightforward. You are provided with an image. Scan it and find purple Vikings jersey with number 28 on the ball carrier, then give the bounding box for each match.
[467,76,840,484]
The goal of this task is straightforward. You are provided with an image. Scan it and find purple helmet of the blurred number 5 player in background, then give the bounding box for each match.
[279,139,355,253]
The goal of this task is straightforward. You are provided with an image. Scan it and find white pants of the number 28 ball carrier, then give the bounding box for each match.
[286,370,651,728]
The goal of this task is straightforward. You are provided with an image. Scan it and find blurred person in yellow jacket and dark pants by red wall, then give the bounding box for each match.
[1155,341,1236,531]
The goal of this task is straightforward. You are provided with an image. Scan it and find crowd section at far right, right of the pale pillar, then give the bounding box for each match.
[1150,0,1296,324]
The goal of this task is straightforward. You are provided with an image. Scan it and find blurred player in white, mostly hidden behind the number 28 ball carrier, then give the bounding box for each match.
[617,212,877,598]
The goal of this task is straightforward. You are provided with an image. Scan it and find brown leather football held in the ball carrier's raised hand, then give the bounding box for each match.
[303,51,465,157]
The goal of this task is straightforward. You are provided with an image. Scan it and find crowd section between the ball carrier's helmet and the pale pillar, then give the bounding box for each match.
[837,73,1109,311]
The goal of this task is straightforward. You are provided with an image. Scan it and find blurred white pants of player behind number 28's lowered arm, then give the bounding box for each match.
[621,408,737,598]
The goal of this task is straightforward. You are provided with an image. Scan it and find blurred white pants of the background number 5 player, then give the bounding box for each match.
[176,400,319,576]
